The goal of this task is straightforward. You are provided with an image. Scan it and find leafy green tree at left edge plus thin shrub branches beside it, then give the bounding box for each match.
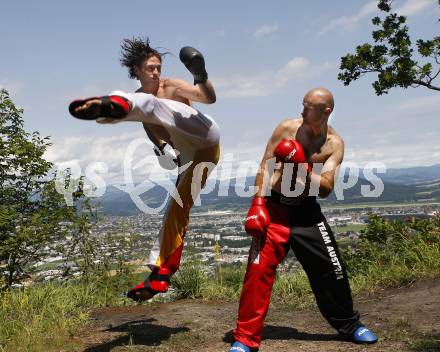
[0,90,114,289]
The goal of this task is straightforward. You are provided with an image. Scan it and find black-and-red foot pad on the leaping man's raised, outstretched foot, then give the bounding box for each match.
[69,95,131,120]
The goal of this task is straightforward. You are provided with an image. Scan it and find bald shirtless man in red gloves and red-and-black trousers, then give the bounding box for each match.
[230,88,377,352]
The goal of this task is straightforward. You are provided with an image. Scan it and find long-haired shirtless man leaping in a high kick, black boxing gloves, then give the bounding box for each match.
[69,38,220,301]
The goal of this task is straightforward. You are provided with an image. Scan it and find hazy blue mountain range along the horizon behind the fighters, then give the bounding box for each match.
[97,165,440,215]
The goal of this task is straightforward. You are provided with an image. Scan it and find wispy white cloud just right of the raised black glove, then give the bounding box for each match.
[215,57,332,97]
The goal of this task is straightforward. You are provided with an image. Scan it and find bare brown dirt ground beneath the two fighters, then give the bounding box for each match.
[72,279,440,352]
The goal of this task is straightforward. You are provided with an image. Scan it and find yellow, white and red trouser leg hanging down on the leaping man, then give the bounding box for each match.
[149,144,220,279]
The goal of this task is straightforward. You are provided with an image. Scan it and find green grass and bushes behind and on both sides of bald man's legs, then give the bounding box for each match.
[172,215,440,307]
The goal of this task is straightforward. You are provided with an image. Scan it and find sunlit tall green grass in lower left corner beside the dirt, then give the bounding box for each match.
[0,270,138,352]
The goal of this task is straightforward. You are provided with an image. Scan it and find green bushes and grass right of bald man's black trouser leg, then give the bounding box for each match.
[343,215,440,291]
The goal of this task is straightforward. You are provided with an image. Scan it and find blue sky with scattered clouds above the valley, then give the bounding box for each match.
[0,0,440,184]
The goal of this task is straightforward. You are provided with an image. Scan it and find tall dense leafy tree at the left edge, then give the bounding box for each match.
[0,89,76,289]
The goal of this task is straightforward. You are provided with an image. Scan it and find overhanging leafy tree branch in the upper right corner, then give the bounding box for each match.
[338,0,440,95]
